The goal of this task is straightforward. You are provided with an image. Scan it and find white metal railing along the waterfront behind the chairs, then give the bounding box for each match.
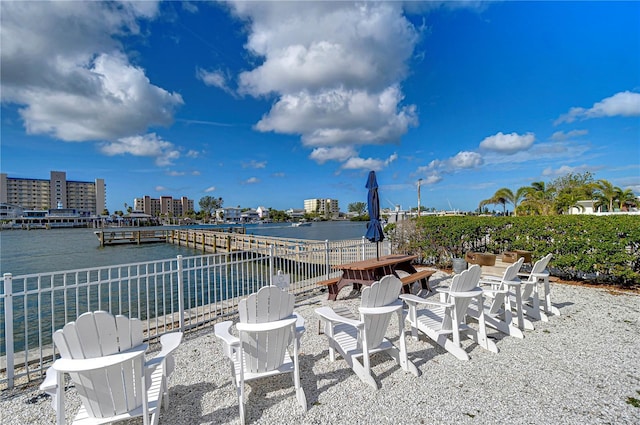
[0,238,390,388]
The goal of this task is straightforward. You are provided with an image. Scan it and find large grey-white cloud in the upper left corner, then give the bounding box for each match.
[0,1,183,151]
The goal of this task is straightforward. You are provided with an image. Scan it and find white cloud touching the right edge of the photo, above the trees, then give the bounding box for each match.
[554,91,640,125]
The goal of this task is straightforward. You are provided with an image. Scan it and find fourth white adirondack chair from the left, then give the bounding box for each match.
[400,264,498,360]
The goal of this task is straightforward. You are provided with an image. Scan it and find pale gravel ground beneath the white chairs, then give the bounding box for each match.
[0,272,640,424]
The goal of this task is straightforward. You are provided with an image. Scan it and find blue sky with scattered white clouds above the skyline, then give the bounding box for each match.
[0,1,640,212]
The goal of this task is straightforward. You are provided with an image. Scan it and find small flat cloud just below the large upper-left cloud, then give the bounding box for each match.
[100,133,180,166]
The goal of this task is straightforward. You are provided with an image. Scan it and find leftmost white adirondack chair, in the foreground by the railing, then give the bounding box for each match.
[40,311,182,425]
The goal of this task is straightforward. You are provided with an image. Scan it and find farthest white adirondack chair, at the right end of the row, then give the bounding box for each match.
[518,254,560,322]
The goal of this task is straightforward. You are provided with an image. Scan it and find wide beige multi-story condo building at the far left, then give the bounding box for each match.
[0,171,107,215]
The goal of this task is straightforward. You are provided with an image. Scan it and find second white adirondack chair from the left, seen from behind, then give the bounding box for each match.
[214,286,307,424]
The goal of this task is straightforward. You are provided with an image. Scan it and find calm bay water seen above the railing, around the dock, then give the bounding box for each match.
[0,222,366,276]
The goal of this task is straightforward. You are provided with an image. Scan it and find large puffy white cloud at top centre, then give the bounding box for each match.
[225,1,419,154]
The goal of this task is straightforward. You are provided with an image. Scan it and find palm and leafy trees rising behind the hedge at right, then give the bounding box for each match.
[478,171,638,216]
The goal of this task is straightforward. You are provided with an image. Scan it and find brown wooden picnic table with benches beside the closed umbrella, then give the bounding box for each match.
[325,255,434,301]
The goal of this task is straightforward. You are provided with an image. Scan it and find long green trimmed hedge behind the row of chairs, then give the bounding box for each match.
[389,215,640,286]
